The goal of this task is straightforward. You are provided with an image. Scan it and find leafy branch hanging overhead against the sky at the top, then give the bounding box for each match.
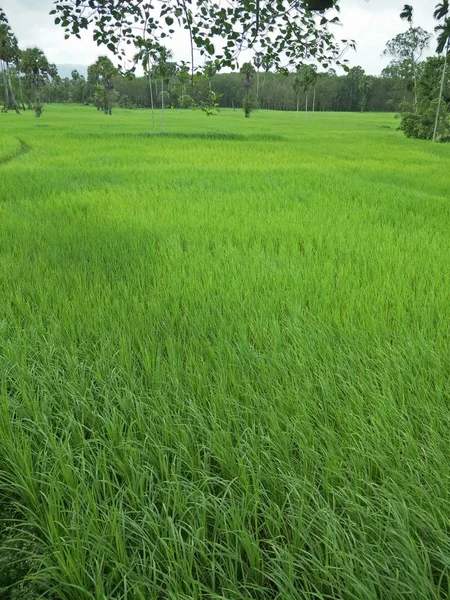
[51,0,354,69]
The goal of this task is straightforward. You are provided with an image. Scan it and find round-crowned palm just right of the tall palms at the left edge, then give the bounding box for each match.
[20,47,58,117]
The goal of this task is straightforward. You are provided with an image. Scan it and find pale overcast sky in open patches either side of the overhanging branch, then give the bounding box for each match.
[0,0,438,75]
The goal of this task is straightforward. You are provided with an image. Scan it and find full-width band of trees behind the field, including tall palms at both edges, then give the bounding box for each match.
[0,0,450,141]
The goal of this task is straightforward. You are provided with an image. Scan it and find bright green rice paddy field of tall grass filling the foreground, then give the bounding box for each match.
[0,106,450,600]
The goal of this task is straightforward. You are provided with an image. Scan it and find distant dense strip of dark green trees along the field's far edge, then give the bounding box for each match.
[37,63,398,111]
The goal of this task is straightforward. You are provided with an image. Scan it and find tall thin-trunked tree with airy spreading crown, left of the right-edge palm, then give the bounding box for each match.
[383,25,431,111]
